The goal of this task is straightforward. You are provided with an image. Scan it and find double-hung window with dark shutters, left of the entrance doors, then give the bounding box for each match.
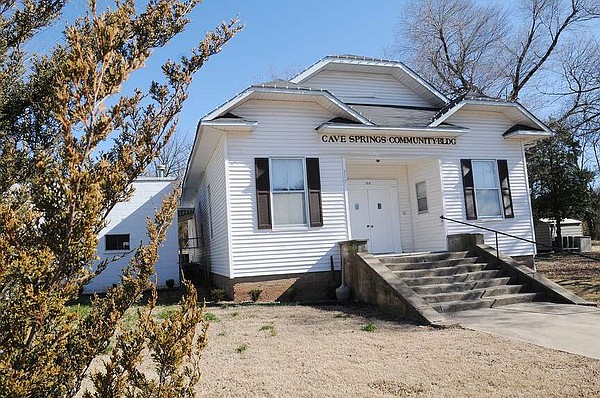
[254,158,323,229]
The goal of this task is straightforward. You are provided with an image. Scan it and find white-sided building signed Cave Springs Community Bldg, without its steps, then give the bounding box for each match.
[181,56,552,299]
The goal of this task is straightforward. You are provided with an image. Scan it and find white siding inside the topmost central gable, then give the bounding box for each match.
[302,70,432,107]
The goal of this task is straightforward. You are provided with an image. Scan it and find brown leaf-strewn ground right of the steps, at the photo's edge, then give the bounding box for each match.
[535,252,600,303]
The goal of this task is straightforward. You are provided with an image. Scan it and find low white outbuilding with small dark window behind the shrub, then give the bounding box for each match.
[84,177,180,293]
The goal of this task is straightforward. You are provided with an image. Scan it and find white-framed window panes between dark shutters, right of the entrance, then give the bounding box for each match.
[472,160,502,218]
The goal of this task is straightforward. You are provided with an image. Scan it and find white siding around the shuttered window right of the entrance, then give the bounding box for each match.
[441,111,534,256]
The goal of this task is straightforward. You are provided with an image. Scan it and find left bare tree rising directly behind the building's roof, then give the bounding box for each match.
[396,0,508,94]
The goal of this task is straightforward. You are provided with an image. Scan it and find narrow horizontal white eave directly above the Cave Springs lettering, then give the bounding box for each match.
[315,123,469,137]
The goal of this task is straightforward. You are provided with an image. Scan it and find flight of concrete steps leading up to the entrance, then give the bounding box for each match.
[378,252,540,312]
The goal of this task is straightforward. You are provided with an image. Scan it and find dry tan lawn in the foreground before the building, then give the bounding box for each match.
[198,305,600,397]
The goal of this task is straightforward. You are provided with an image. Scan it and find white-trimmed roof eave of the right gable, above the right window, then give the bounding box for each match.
[429,100,552,134]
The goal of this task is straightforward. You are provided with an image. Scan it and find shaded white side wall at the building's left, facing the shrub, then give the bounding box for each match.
[196,137,232,276]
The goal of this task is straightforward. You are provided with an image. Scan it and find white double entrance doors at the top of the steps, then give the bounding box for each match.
[348,181,401,253]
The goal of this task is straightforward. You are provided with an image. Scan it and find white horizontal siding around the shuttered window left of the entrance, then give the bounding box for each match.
[227,101,348,277]
